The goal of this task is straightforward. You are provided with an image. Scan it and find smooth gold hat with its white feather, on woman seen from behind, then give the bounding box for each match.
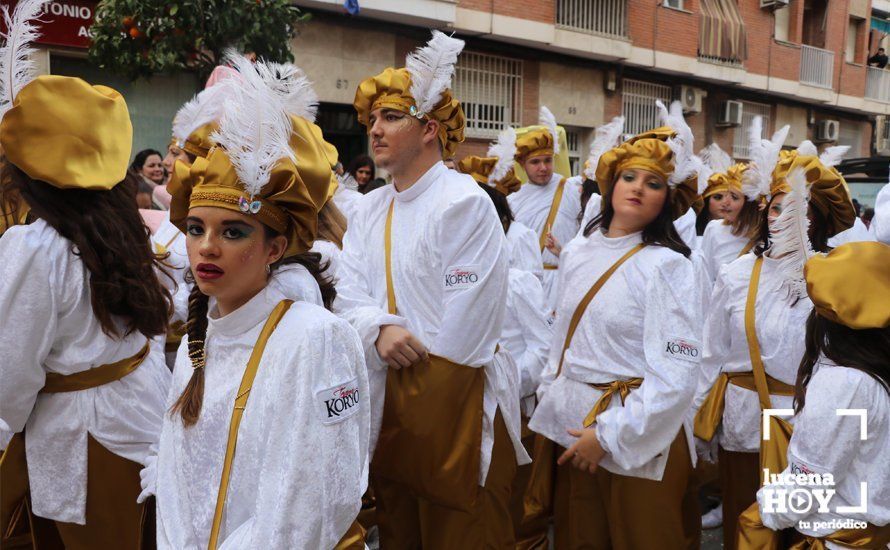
[0,0,133,190]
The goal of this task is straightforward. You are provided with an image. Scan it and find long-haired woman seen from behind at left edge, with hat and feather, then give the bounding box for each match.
[0,0,171,549]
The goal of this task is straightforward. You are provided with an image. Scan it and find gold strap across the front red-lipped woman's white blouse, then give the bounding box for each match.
[207,300,294,550]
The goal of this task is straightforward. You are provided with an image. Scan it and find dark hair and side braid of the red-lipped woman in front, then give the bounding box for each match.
[170,225,337,426]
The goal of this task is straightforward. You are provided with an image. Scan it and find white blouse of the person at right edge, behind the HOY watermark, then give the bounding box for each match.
[757,357,890,548]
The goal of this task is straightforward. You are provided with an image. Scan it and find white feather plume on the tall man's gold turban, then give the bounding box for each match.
[405,31,464,115]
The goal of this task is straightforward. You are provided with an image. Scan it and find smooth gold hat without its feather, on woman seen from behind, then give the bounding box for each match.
[0,75,133,190]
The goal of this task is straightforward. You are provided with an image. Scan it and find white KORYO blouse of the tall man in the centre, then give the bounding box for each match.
[334,162,525,482]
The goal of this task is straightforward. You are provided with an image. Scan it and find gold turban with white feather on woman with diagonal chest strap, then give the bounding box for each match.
[596,101,702,219]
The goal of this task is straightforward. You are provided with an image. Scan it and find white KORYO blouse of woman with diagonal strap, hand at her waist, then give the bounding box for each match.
[529,231,701,480]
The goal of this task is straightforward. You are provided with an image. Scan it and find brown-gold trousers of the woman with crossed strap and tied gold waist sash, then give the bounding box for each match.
[554,430,701,550]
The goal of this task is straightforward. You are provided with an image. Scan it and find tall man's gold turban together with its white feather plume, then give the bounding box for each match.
[353,31,466,158]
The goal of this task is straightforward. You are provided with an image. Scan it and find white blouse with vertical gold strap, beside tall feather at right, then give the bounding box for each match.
[695,254,813,453]
